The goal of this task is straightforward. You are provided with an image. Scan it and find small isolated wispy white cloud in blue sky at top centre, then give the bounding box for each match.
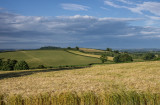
[61,3,89,11]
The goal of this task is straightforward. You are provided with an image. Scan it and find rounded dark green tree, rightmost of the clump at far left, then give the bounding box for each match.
[14,61,29,70]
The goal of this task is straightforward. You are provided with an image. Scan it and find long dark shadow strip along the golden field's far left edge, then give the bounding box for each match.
[0,66,90,80]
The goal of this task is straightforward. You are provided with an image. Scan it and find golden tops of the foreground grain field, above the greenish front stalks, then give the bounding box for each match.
[0,61,160,96]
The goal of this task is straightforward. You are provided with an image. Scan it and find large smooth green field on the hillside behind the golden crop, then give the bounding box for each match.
[0,50,100,68]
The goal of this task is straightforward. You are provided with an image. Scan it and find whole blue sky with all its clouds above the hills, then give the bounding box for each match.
[0,0,160,49]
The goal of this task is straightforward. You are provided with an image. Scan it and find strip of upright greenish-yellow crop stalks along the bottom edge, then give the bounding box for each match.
[0,92,160,105]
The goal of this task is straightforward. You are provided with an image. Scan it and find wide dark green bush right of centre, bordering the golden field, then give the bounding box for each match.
[113,54,133,63]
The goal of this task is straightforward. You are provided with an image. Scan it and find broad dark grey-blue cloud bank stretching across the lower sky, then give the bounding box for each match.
[0,13,160,48]
